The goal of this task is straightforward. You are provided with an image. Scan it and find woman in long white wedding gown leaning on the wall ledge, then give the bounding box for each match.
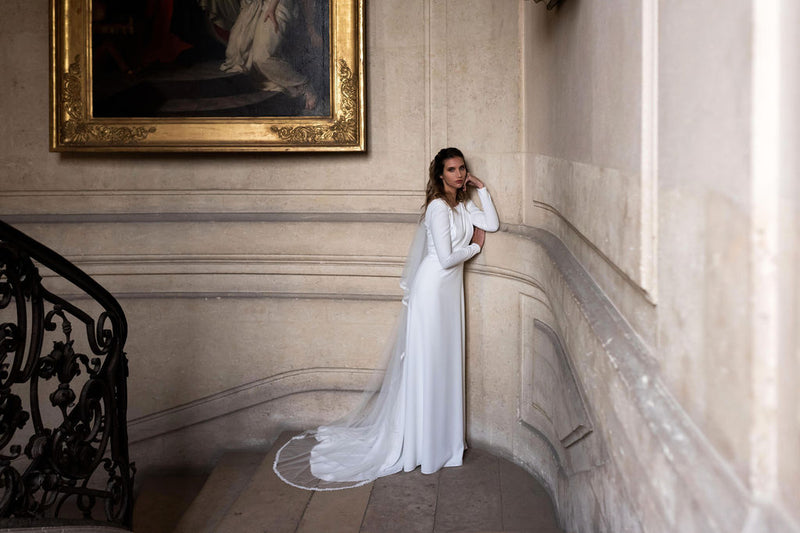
[274,148,499,490]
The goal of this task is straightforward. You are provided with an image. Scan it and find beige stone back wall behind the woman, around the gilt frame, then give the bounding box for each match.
[0,1,522,469]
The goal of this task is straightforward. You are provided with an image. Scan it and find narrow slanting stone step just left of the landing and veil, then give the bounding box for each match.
[174,451,264,533]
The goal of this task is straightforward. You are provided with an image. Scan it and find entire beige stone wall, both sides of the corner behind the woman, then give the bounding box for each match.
[0,0,800,533]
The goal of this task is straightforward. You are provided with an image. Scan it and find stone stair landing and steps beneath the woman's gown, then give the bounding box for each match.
[134,433,561,533]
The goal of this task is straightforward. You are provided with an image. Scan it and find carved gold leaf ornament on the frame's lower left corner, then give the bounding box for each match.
[61,56,156,144]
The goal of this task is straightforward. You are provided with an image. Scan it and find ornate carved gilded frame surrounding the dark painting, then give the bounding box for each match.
[50,0,366,152]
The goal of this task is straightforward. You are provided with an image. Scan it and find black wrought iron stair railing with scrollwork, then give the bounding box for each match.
[0,221,135,528]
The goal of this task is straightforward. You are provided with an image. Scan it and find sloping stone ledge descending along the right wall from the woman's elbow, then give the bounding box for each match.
[503,226,798,533]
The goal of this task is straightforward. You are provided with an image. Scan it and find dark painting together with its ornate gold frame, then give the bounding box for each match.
[50,0,366,152]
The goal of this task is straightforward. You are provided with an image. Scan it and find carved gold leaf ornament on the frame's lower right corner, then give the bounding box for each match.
[271,59,358,144]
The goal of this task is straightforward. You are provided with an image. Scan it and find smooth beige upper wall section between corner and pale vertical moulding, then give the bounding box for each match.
[521,0,643,173]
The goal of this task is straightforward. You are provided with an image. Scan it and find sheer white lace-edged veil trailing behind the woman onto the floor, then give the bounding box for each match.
[273,223,427,491]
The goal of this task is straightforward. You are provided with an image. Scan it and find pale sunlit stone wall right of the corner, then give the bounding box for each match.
[524,1,800,531]
